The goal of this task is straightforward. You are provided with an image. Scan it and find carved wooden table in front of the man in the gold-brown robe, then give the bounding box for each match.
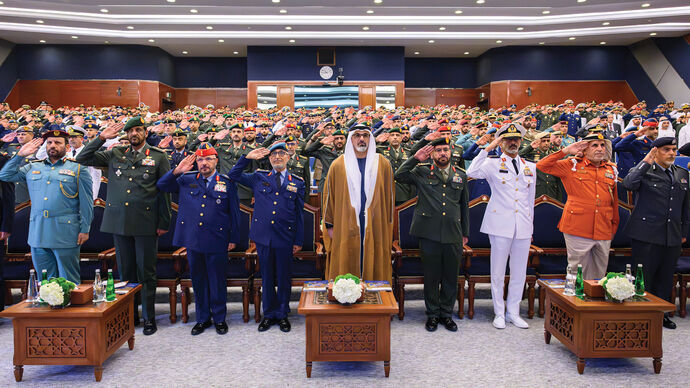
[297,291,398,377]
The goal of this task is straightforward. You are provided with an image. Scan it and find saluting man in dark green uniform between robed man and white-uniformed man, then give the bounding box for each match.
[395,137,470,331]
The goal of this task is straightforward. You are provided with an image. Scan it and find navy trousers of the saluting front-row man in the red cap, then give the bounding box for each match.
[187,250,228,323]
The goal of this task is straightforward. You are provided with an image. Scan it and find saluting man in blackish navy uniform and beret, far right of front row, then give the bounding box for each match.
[623,137,690,329]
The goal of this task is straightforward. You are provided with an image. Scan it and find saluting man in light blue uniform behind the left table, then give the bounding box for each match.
[0,130,93,284]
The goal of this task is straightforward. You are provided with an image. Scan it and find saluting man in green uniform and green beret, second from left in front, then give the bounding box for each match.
[76,117,170,335]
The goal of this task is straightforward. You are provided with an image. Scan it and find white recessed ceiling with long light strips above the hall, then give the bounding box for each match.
[0,0,690,58]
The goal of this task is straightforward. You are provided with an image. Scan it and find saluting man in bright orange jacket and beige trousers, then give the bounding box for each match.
[537,133,618,279]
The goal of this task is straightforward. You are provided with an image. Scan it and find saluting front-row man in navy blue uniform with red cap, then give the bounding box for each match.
[157,143,240,335]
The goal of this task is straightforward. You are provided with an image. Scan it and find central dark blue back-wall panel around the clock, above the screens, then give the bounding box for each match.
[247,46,405,81]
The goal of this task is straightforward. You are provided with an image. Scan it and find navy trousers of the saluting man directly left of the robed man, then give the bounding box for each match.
[256,244,292,319]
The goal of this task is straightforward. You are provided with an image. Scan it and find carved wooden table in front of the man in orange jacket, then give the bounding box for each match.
[539,280,675,374]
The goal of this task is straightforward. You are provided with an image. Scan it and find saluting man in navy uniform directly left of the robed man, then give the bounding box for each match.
[228,142,305,332]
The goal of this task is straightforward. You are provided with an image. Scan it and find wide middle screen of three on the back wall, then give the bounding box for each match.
[294,86,359,109]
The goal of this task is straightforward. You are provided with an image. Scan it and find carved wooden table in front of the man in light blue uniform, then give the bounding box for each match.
[0,285,141,381]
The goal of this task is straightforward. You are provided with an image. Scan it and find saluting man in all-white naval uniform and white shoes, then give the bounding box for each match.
[467,123,537,329]
